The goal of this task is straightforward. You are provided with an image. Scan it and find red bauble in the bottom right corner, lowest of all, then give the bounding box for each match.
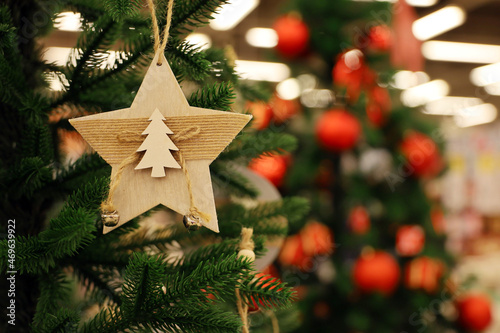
[457,294,492,331]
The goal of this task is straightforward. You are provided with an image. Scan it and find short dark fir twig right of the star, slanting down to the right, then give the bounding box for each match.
[210,161,259,198]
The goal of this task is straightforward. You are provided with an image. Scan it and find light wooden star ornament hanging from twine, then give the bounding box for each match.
[70,52,251,233]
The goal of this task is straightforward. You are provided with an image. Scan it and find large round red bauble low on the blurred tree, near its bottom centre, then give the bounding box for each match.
[353,251,401,295]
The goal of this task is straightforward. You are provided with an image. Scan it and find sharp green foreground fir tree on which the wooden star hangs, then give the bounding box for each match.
[0,0,308,332]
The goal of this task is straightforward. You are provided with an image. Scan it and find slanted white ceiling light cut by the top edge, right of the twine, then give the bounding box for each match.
[210,0,259,31]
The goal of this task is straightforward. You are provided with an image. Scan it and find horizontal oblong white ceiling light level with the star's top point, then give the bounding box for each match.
[235,60,290,82]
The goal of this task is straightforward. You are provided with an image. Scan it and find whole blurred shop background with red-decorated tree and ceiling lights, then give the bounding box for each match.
[41,0,500,333]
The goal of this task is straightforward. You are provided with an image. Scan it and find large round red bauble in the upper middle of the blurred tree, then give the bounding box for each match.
[316,109,361,151]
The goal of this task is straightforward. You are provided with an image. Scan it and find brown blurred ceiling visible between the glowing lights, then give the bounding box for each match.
[44,0,500,121]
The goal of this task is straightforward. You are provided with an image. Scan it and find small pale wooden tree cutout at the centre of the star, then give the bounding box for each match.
[135,109,181,177]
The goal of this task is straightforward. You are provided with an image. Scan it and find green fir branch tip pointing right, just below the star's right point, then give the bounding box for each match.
[218,130,298,161]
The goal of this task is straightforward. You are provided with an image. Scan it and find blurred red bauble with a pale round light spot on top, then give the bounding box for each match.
[332,49,366,102]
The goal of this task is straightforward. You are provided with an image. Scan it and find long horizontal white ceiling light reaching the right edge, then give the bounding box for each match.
[422,41,500,64]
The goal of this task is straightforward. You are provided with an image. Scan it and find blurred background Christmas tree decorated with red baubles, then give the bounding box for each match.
[244,0,491,333]
